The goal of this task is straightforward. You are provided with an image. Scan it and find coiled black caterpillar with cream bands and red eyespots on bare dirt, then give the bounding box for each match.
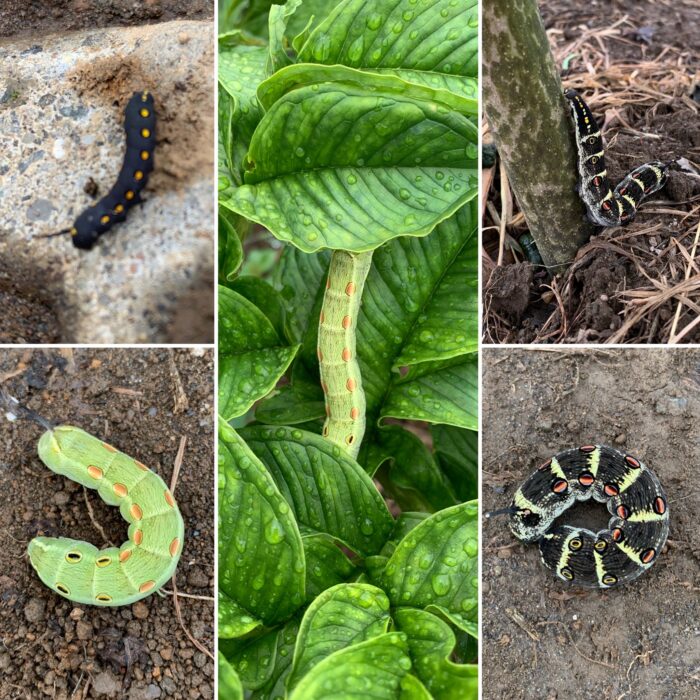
[490,445,669,588]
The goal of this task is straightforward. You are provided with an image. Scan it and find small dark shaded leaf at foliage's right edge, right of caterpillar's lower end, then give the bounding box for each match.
[430,425,479,501]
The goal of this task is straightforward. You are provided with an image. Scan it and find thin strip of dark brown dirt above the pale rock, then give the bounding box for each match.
[0,0,214,37]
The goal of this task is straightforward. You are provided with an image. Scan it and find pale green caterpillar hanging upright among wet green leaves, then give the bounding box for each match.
[318,250,372,457]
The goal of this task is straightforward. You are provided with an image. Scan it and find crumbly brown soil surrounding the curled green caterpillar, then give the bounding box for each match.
[0,349,214,700]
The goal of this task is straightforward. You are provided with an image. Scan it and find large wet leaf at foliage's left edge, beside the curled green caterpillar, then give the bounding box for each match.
[219,421,305,625]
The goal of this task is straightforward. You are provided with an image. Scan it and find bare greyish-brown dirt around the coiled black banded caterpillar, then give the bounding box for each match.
[482,348,700,700]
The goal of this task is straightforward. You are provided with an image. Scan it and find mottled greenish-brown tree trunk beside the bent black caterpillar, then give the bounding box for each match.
[482,0,593,272]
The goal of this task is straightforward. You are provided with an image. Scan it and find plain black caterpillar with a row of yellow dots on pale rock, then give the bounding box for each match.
[49,90,156,250]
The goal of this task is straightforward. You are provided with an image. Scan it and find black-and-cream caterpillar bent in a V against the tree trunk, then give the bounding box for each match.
[564,90,670,226]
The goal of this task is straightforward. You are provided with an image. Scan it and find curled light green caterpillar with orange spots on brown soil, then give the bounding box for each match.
[3,394,185,606]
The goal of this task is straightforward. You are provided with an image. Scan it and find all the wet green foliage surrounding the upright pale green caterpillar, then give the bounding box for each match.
[218,0,478,700]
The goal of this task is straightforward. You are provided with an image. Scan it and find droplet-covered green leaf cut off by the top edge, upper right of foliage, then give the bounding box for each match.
[299,0,478,78]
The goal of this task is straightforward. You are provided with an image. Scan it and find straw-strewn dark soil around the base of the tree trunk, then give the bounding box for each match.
[483,0,700,343]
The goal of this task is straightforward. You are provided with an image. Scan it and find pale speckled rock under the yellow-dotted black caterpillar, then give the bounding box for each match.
[0,21,215,343]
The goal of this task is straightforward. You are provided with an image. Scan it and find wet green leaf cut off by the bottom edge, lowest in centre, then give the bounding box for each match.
[290,632,411,700]
